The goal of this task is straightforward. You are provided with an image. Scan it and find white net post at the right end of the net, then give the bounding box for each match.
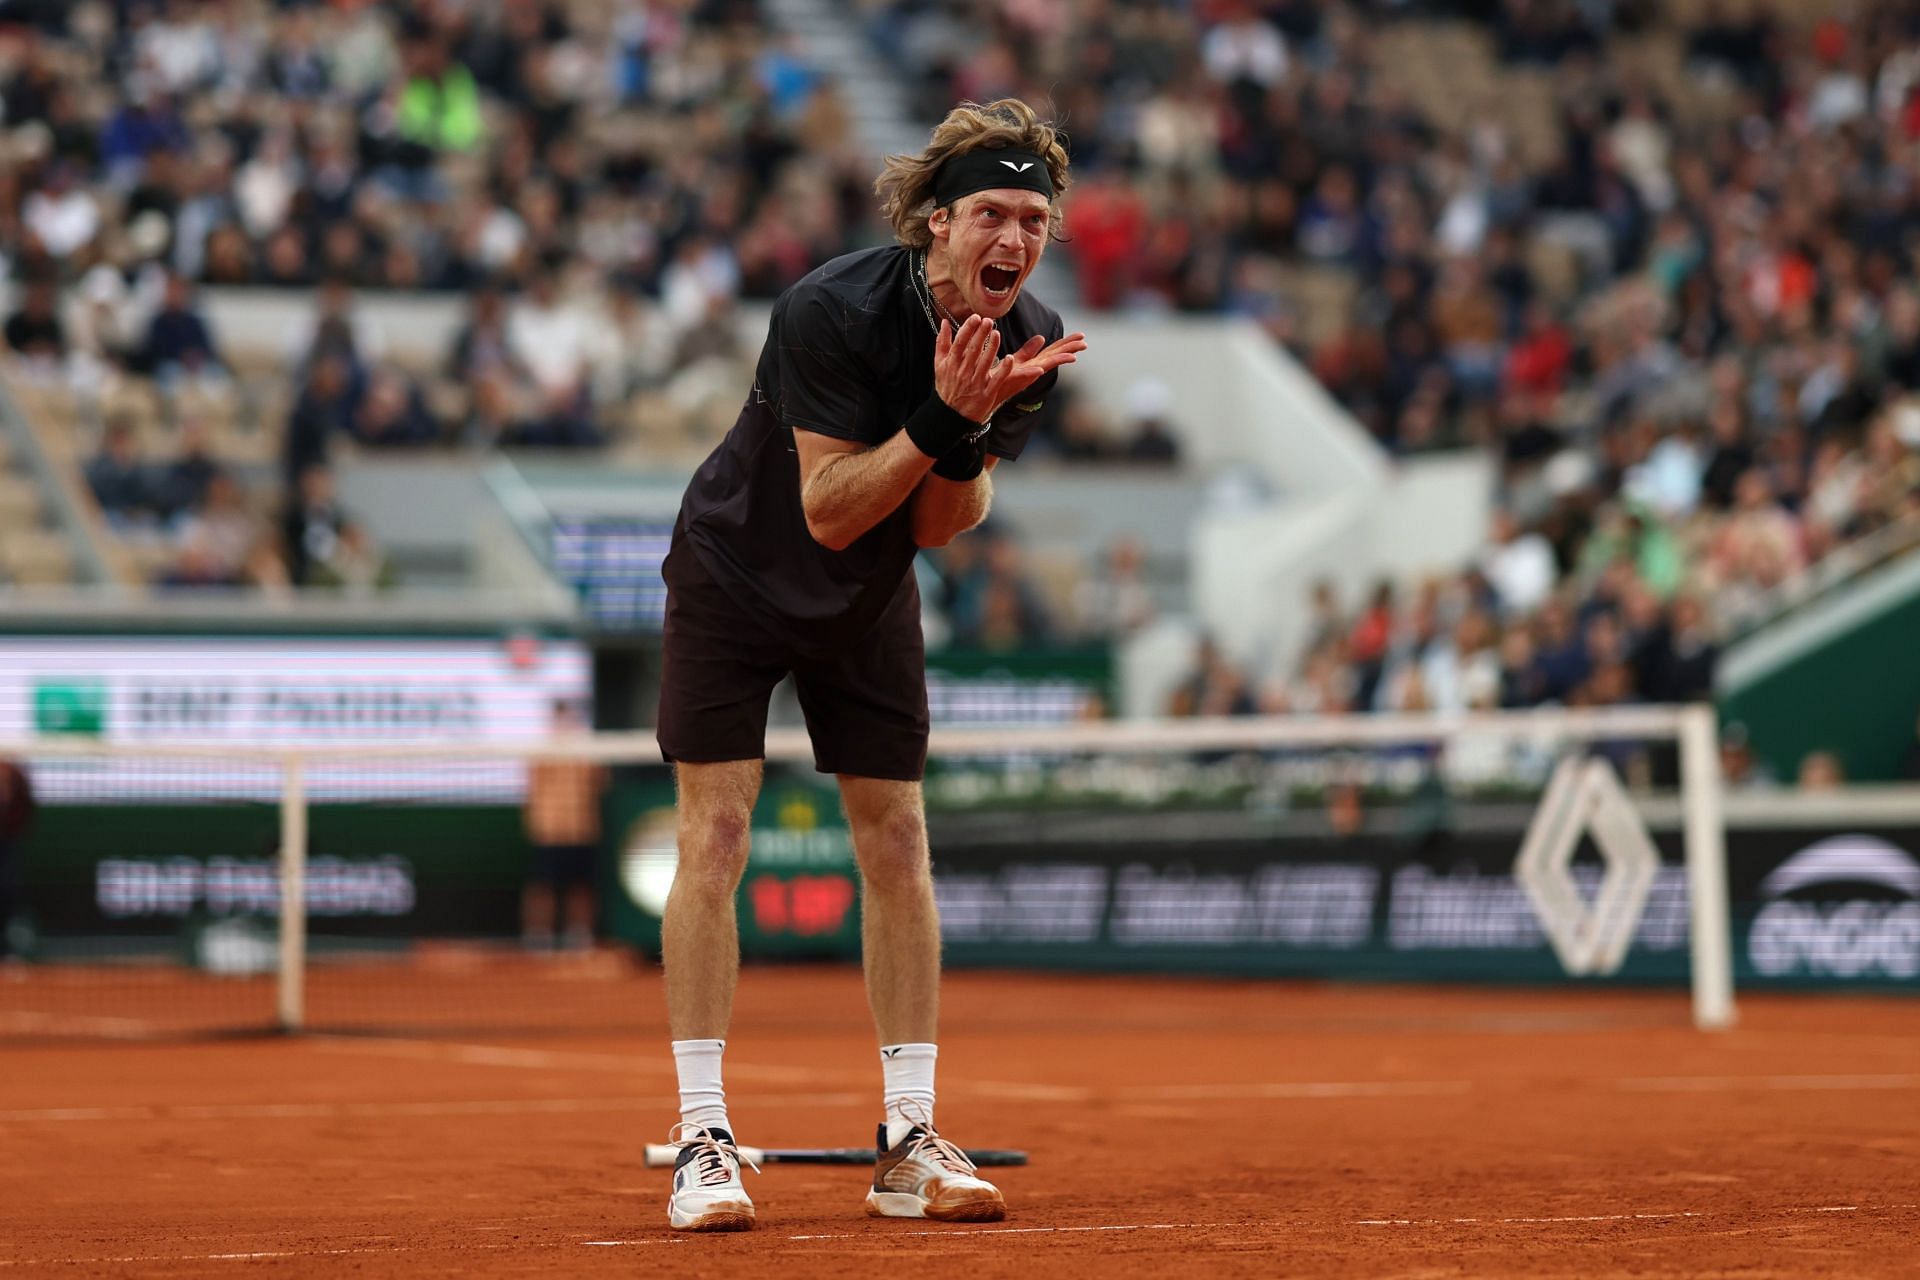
[1680,702,1734,1031]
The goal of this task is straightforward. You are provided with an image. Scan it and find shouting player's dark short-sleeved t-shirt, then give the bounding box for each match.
[676,246,1062,652]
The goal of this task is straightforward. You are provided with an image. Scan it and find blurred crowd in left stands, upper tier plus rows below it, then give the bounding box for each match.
[0,0,876,587]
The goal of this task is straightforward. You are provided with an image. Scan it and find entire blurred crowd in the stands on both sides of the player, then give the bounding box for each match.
[0,0,1920,652]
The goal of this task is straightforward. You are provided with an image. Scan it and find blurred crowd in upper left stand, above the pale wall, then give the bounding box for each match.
[0,0,872,297]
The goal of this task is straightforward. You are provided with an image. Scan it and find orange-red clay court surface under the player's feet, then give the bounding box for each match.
[0,965,1920,1278]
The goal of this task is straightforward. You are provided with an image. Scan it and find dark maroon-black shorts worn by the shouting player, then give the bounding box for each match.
[659,539,927,781]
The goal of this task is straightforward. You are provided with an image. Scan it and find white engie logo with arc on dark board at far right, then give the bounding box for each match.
[1747,835,1920,979]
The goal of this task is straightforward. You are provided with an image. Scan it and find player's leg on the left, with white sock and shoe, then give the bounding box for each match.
[660,760,760,1230]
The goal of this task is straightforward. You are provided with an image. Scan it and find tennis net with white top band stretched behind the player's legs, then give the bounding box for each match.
[0,708,1732,1038]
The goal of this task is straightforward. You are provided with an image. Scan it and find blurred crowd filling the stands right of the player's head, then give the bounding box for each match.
[864,0,1889,729]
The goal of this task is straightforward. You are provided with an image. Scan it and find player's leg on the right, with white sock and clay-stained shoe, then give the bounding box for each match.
[841,773,1006,1222]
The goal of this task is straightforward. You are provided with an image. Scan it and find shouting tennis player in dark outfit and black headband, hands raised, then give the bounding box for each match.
[659,100,1087,1230]
